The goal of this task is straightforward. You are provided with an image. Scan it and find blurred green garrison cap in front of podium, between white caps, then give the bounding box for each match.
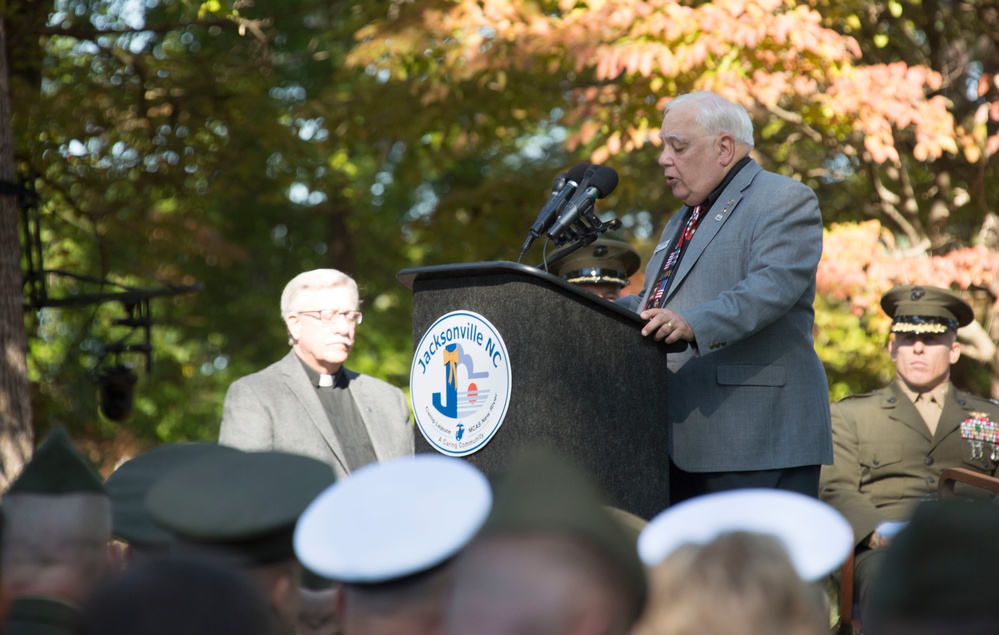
[481,446,646,607]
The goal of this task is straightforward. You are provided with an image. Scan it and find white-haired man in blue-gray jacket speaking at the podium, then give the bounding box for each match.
[620,92,832,503]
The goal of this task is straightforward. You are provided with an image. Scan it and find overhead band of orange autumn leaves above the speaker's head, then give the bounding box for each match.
[349,0,999,163]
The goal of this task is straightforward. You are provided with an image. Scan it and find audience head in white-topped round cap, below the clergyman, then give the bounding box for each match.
[295,454,492,635]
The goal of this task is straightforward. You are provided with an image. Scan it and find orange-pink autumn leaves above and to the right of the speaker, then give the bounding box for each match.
[348,0,999,396]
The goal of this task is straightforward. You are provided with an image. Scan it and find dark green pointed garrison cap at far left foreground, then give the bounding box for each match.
[7,426,105,494]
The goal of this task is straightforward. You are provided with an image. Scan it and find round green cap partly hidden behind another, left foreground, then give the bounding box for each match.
[105,443,238,549]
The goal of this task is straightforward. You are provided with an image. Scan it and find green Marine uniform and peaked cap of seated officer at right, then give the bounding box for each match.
[819,285,999,609]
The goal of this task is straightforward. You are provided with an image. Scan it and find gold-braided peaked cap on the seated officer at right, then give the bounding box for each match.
[881,284,975,333]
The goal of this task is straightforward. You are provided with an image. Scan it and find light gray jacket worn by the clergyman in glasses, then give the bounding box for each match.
[219,351,414,478]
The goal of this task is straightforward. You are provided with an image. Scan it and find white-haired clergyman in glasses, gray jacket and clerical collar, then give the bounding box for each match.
[219,269,414,478]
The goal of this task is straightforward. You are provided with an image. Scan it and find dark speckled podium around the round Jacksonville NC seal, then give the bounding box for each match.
[397,261,685,519]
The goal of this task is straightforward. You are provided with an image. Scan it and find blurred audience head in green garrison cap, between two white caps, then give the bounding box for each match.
[442,448,646,635]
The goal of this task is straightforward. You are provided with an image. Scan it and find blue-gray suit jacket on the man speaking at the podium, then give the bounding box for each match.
[622,162,832,472]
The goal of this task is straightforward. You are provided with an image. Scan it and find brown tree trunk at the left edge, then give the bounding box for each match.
[0,15,34,492]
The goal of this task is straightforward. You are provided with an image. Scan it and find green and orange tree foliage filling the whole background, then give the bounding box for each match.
[0,0,999,468]
